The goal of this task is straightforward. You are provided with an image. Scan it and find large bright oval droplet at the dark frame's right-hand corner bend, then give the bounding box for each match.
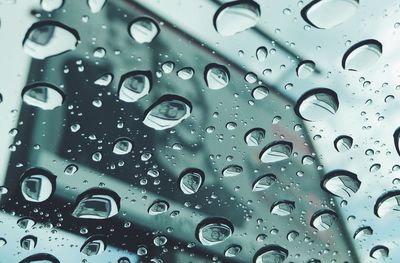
[295,88,339,121]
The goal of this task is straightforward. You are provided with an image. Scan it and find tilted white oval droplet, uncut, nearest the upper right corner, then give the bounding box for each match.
[342,39,383,71]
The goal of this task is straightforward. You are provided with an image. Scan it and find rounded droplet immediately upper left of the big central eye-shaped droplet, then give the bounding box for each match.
[118,70,151,102]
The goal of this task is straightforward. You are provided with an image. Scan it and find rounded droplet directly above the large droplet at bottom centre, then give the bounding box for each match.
[179,168,204,195]
